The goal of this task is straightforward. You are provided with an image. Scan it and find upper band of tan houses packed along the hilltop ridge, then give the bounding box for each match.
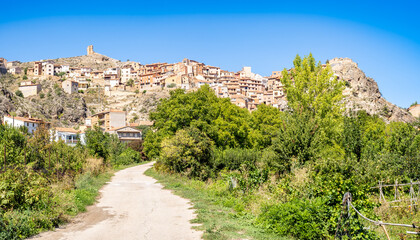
[0,45,285,111]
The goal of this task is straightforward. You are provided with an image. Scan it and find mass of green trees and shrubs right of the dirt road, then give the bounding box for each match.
[144,55,420,239]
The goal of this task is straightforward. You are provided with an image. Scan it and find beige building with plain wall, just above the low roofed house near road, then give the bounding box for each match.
[90,110,126,130]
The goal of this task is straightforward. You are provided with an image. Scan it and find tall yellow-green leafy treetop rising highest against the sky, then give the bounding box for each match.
[281,54,345,142]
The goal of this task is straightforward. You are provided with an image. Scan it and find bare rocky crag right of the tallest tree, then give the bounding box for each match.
[329,58,415,122]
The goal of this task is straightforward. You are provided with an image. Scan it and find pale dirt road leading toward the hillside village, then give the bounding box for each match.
[34,163,202,240]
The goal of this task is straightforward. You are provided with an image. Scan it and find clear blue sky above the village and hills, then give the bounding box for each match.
[0,0,420,107]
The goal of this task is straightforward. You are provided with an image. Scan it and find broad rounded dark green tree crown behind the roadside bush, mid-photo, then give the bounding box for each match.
[145,86,251,160]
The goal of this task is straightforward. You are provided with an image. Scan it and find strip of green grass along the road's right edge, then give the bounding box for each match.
[145,168,290,240]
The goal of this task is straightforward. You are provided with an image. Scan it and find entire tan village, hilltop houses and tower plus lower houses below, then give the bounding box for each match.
[0,45,286,145]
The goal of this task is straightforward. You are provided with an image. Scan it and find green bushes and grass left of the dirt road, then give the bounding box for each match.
[0,125,142,239]
